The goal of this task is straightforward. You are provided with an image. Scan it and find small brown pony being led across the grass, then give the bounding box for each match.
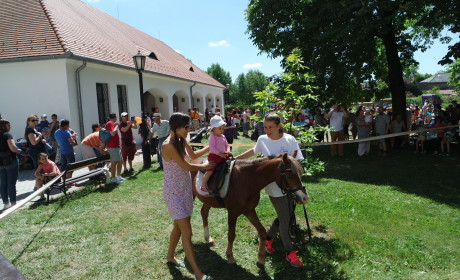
[192,154,308,265]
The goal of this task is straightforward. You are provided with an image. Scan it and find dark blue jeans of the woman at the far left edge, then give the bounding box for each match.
[0,159,19,204]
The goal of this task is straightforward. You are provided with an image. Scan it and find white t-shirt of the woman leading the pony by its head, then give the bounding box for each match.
[254,133,303,197]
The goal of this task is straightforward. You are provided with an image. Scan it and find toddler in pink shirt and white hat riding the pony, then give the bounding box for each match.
[201,116,230,192]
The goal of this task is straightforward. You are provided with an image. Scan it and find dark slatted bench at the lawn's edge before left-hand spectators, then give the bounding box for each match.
[45,155,110,204]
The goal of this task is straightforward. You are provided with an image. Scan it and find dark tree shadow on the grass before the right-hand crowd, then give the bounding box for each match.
[307,144,460,208]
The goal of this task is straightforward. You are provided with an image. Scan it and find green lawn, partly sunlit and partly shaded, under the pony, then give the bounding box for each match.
[0,135,460,279]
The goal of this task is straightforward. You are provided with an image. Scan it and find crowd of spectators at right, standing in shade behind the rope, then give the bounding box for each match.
[295,100,460,157]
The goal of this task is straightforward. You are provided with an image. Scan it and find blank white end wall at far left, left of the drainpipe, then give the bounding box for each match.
[0,59,73,140]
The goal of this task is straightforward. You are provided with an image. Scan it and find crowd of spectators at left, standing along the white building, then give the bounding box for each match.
[0,112,174,209]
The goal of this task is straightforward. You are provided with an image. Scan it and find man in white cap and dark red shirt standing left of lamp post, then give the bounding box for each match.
[120,112,137,172]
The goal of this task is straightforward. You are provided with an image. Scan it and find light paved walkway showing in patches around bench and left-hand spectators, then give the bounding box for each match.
[16,149,153,206]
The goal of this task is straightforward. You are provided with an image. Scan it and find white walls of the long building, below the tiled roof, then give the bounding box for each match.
[0,58,223,158]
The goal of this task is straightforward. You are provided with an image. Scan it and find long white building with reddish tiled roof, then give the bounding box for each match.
[0,0,225,145]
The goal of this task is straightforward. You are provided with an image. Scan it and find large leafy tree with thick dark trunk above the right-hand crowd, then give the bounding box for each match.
[246,0,460,119]
